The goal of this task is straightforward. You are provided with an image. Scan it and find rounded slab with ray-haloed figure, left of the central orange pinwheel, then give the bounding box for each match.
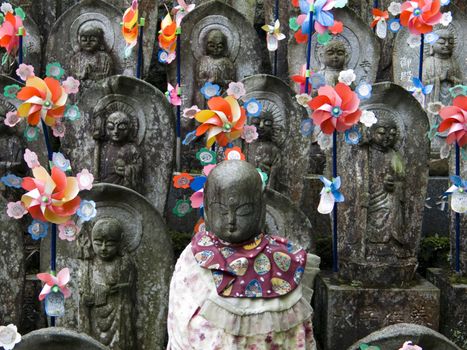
[62,76,175,213]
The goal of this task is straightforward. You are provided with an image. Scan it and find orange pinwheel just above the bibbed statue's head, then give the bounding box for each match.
[195,96,246,147]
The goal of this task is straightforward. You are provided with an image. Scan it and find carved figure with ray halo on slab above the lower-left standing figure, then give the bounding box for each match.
[94,111,143,192]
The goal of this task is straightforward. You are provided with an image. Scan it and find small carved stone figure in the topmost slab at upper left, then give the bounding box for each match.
[71,22,113,84]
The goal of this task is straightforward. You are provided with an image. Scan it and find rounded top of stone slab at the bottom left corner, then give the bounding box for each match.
[15,327,109,350]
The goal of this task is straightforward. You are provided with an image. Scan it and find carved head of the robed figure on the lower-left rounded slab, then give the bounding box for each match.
[92,219,123,261]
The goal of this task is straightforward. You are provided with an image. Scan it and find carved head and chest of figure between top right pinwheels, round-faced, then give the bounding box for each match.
[318,40,349,86]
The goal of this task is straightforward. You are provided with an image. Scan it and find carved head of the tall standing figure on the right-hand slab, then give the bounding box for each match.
[369,113,398,152]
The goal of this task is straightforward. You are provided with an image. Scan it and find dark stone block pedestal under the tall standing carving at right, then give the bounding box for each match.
[313,272,440,350]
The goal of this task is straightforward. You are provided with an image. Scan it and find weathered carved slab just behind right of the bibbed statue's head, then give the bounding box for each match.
[242,74,311,203]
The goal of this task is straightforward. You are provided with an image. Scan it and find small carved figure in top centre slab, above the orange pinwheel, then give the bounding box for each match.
[196,29,236,108]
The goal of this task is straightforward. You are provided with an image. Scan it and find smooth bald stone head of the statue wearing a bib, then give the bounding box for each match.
[204,160,265,243]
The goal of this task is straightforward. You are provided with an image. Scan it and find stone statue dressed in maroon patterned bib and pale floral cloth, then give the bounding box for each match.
[167,160,319,350]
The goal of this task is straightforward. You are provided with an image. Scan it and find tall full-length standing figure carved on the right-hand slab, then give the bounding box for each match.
[367,112,410,257]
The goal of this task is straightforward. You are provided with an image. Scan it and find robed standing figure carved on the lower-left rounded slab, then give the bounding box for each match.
[80,218,136,350]
